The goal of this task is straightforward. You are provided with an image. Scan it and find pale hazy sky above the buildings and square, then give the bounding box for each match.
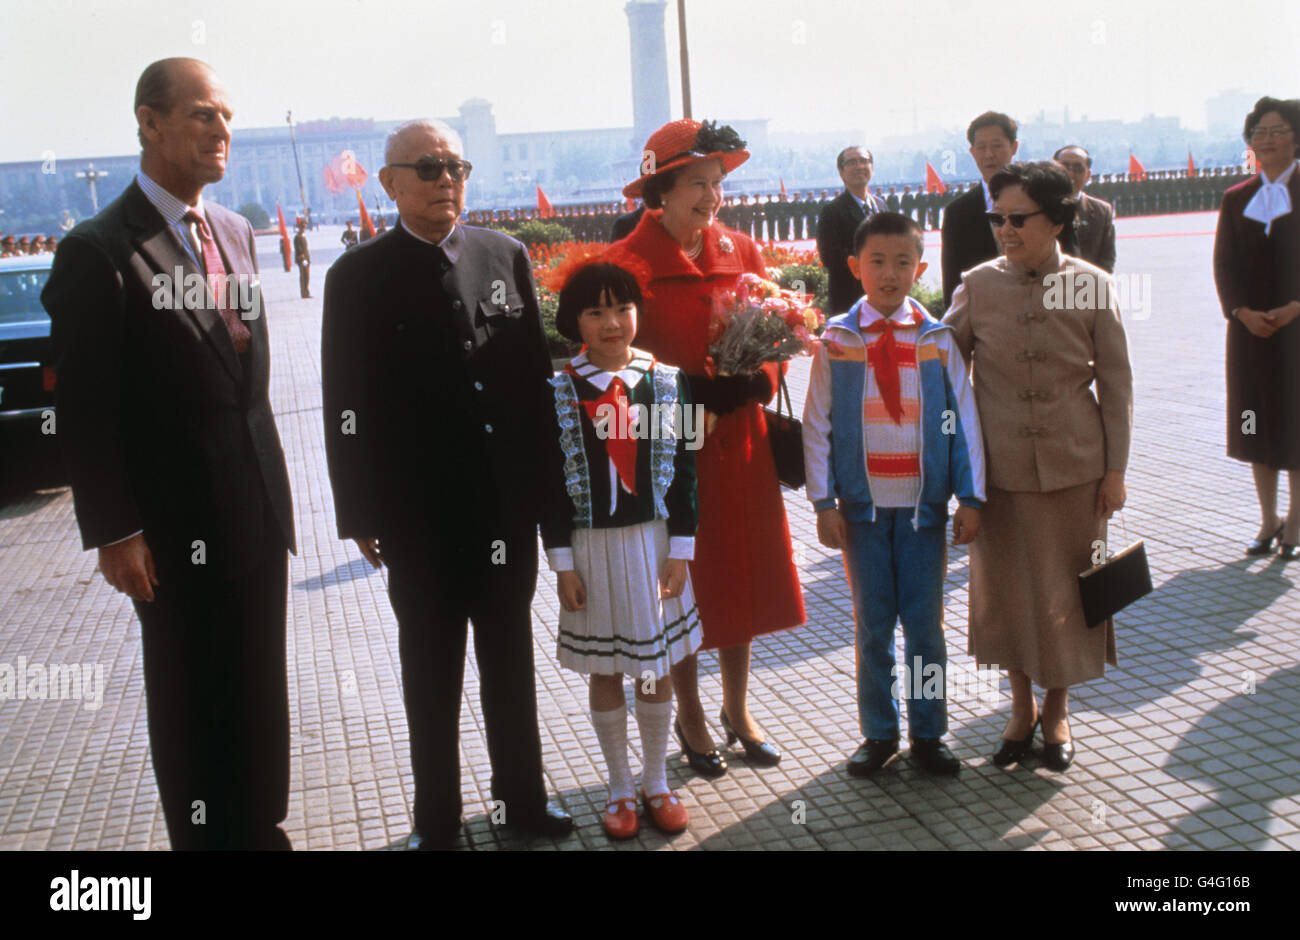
[0,0,1300,161]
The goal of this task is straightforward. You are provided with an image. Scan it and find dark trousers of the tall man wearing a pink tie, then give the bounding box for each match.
[135,525,291,850]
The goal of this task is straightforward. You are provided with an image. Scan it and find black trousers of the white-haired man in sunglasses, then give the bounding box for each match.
[380,528,546,839]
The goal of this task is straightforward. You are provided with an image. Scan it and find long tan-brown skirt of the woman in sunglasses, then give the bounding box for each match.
[967,480,1117,689]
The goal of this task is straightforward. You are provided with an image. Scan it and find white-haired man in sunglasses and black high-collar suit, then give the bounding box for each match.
[321,121,573,849]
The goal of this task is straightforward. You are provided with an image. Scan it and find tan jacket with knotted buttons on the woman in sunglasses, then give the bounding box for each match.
[944,250,1132,491]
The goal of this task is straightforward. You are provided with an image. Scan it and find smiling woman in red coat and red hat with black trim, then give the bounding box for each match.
[610,120,805,776]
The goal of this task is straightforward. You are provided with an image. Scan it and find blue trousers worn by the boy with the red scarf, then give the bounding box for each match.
[844,508,948,738]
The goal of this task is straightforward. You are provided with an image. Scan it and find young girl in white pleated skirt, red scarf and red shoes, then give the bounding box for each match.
[542,261,702,839]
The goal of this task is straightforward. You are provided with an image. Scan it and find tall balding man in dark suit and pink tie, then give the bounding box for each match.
[42,59,294,849]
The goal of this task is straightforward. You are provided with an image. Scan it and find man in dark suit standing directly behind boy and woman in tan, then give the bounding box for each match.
[940,111,1021,307]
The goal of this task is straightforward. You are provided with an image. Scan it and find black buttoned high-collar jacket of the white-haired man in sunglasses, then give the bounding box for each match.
[321,225,555,548]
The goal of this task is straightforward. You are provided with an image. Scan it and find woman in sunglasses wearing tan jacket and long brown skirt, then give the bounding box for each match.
[944,163,1132,771]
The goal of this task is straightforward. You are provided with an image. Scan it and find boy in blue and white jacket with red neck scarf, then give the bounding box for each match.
[803,212,984,776]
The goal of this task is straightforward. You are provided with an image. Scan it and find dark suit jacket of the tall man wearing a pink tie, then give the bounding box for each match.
[42,182,294,579]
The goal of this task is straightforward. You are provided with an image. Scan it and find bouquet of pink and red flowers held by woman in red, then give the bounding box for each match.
[705,274,826,433]
